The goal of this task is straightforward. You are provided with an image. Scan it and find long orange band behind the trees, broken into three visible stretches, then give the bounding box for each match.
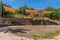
[4,6,54,14]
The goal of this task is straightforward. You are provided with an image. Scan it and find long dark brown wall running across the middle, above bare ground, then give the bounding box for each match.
[0,18,59,27]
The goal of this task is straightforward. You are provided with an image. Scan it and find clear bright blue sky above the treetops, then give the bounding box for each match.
[2,0,60,9]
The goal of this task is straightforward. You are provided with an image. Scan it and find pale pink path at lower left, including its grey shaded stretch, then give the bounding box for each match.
[0,26,32,40]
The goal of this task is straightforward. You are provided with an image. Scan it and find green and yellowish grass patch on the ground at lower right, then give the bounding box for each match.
[31,30,60,39]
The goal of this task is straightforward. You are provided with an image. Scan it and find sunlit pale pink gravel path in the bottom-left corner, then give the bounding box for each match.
[0,32,32,40]
